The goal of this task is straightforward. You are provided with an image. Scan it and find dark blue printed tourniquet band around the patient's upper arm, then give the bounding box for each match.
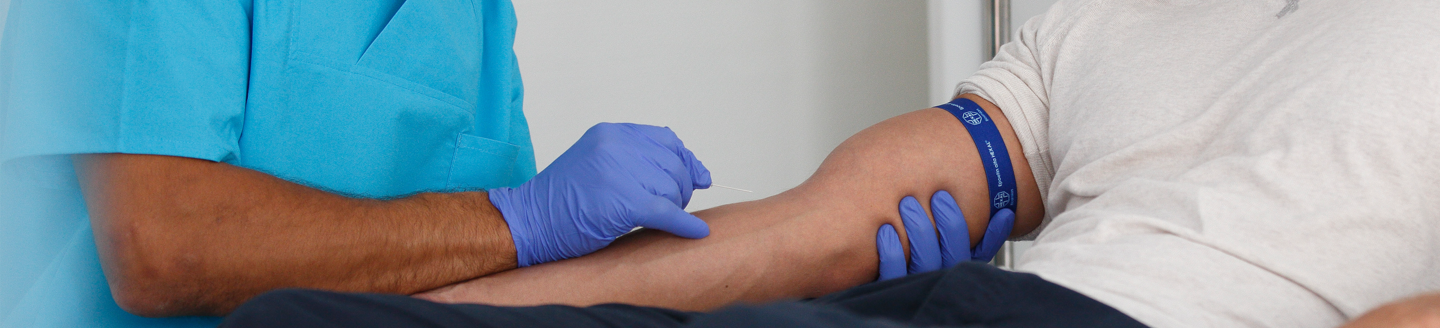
[936,98,1018,217]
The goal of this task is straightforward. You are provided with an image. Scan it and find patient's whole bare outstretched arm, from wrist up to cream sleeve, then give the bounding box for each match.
[416,95,1043,311]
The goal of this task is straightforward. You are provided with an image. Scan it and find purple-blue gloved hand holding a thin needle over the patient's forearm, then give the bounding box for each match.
[490,124,710,266]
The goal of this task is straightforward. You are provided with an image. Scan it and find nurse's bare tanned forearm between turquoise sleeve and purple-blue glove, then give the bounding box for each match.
[72,154,516,316]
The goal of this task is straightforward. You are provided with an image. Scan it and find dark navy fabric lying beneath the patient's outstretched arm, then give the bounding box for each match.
[220,263,1145,328]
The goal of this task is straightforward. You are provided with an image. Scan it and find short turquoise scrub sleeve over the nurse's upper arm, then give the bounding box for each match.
[0,0,251,163]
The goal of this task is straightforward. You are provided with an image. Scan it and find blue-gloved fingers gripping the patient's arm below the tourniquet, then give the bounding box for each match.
[876,190,1015,281]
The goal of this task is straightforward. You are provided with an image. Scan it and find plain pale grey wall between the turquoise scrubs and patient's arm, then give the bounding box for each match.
[514,0,933,210]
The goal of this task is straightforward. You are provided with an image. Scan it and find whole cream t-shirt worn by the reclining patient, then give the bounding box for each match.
[959,0,1440,327]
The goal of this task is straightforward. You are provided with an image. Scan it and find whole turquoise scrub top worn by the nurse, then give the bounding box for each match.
[0,0,536,327]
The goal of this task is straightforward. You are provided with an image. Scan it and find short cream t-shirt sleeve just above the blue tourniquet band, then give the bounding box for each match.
[956,1,1066,240]
